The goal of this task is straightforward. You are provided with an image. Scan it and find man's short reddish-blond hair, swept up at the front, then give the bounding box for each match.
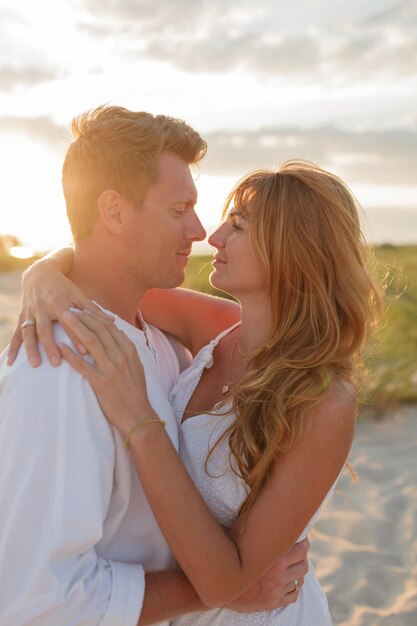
[62,105,207,241]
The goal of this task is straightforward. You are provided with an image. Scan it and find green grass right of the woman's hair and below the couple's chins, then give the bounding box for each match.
[183,245,417,408]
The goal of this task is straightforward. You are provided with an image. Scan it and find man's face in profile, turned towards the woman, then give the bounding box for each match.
[127,152,206,289]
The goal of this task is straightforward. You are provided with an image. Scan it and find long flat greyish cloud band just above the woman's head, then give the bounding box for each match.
[202,127,417,185]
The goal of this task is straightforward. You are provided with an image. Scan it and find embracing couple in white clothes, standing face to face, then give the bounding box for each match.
[0,106,379,626]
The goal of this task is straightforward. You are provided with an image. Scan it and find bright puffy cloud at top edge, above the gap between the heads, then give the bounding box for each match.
[83,0,319,75]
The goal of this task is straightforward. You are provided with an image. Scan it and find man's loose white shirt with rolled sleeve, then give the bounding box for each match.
[0,310,178,626]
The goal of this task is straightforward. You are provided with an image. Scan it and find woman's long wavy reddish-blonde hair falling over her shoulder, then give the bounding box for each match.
[207,161,380,518]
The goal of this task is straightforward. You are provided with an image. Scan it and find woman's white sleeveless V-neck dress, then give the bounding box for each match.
[170,324,337,626]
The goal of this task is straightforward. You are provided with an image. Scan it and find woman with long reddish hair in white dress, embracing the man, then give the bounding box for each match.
[9,162,379,626]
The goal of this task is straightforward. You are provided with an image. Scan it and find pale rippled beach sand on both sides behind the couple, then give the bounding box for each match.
[0,272,417,626]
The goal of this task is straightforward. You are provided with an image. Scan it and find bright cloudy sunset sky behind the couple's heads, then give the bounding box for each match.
[0,0,417,251]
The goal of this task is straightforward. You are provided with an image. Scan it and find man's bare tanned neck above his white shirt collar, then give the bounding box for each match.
[68,245,145,327]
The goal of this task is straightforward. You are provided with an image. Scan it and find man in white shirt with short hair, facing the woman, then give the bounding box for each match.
[0,107,305,626]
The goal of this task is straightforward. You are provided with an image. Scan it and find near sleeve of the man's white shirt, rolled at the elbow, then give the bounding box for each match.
[0,342,145,626]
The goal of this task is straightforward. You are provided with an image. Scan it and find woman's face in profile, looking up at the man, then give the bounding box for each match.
[208,209,268,300]
